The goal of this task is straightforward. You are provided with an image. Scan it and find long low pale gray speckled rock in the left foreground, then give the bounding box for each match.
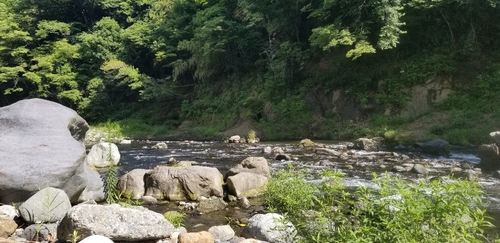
[57,204,174,242]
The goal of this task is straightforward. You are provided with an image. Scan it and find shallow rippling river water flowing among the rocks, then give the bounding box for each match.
[102,141,500,237]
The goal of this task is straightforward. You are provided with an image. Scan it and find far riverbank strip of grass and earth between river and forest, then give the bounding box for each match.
[86,106,498,145]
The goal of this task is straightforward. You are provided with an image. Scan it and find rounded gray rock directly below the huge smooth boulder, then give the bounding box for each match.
[19,187,71,223]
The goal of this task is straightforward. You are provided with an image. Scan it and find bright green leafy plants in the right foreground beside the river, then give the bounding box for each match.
[264,168,492,242]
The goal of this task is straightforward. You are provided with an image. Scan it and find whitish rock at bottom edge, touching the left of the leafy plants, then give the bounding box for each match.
[241,213,297,243]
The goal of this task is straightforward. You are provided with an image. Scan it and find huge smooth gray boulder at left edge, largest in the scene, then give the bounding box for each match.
[0,99,104,204]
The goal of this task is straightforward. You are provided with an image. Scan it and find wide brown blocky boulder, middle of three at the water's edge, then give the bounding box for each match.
[145,166,224,201]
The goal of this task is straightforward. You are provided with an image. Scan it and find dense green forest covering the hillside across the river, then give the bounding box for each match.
[0,0,500,144]
